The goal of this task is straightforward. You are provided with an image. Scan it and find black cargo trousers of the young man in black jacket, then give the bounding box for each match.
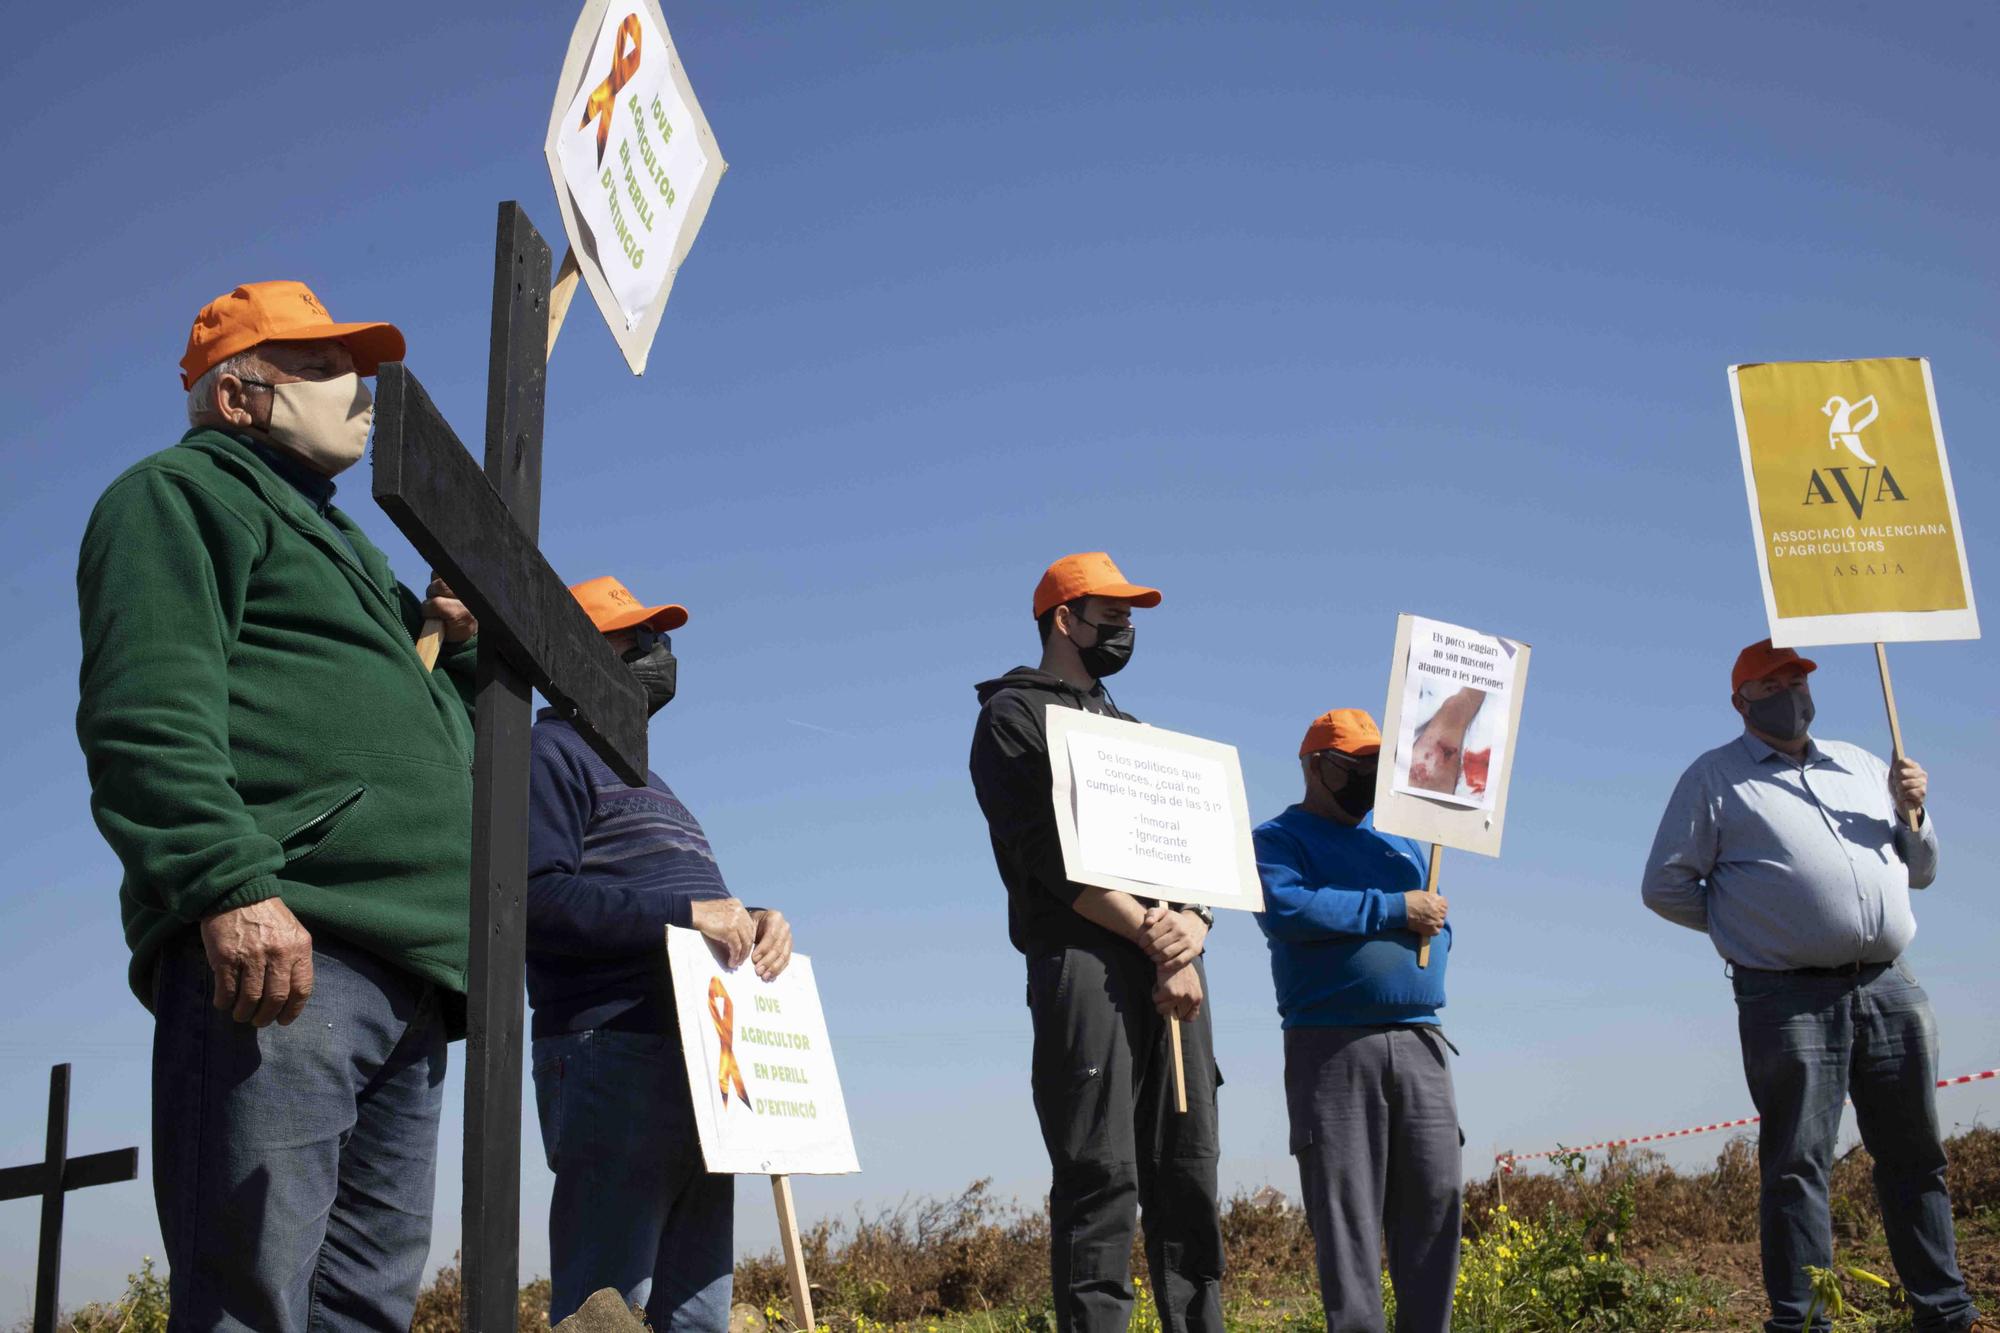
[1028,943,1222,1333]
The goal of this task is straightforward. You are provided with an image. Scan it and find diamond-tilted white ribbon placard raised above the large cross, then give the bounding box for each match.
[542,0,728,374]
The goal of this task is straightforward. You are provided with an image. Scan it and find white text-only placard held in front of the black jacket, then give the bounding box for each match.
[1046,705,1264,913]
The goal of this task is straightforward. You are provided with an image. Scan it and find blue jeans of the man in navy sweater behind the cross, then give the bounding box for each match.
[534,1029,736,1333]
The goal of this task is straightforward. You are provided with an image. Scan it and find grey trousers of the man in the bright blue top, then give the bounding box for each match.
[1284,1027,1464,1333]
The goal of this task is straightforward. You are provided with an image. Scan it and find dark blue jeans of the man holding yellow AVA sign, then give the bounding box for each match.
[1734,963,1978,1333]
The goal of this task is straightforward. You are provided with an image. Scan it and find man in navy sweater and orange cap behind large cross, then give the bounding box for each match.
[528,578,792,1333]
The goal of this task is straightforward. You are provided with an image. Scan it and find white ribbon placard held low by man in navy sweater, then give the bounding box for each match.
[672,927,860,1175]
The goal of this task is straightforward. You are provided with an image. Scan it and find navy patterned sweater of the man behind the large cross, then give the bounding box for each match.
[528,709,730,1037]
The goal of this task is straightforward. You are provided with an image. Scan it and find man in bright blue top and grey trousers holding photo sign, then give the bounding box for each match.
[1256,709,1464,1333]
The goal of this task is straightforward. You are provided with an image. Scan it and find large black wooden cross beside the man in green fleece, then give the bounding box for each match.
[374,202,646,1333]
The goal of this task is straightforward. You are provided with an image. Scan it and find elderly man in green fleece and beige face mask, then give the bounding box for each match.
[76,282,476,1331]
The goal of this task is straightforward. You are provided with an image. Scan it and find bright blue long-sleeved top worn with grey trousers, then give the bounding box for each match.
[1256,805,1452,1027]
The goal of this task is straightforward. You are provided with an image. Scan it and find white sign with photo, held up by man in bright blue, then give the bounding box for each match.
[1374,614,1528,967]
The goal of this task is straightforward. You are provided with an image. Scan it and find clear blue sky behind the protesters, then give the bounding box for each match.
[0,0,2000,1319]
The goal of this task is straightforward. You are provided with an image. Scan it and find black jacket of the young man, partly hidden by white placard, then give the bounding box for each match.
[972,667,1138,955]
